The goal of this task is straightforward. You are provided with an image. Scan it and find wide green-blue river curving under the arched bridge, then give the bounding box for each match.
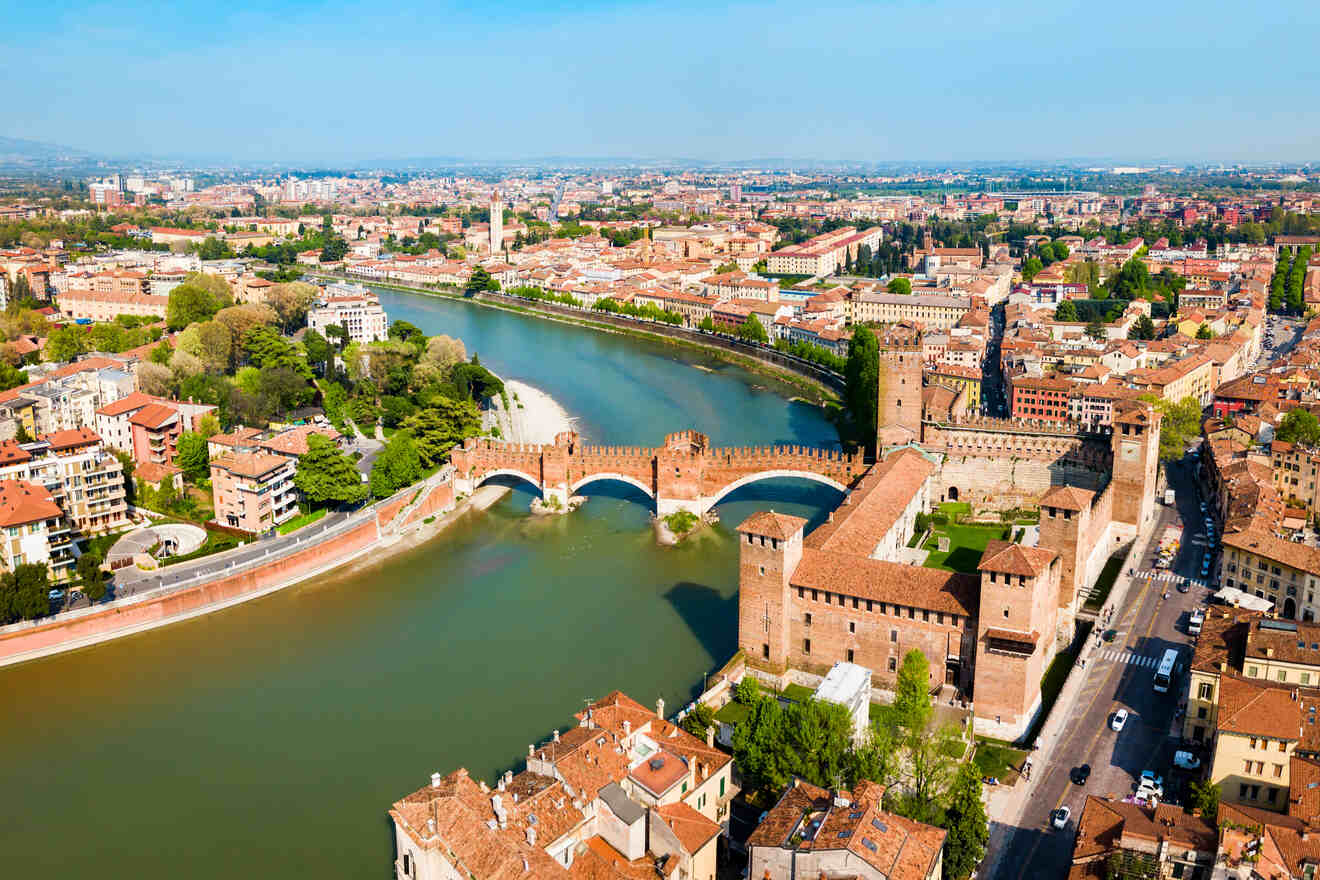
[0,290,837,880]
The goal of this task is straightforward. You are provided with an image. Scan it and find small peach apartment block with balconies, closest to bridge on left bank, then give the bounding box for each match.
[211,453,298,534]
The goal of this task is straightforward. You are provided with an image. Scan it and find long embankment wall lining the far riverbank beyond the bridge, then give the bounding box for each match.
[308,272,845,402]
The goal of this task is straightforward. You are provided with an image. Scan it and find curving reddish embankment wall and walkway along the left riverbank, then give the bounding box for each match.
[0,467,469,666]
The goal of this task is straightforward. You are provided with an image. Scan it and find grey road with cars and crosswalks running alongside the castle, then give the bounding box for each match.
[986,462,1210,880]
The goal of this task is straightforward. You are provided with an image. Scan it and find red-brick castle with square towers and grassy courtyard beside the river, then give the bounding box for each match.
[738,338,1160,739]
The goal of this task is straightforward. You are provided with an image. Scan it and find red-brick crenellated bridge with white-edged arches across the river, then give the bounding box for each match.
[450,431,866,516]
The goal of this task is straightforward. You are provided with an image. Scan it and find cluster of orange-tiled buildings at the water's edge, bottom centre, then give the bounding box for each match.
[389,691,738,880]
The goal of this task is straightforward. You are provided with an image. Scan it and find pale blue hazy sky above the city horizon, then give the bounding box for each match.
[0,0,1320,164]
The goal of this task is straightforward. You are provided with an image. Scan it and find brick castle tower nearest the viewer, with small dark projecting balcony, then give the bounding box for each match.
[974,541,1060,740]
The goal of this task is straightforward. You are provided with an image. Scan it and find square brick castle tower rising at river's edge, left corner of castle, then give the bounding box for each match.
[738,511,807,670]
